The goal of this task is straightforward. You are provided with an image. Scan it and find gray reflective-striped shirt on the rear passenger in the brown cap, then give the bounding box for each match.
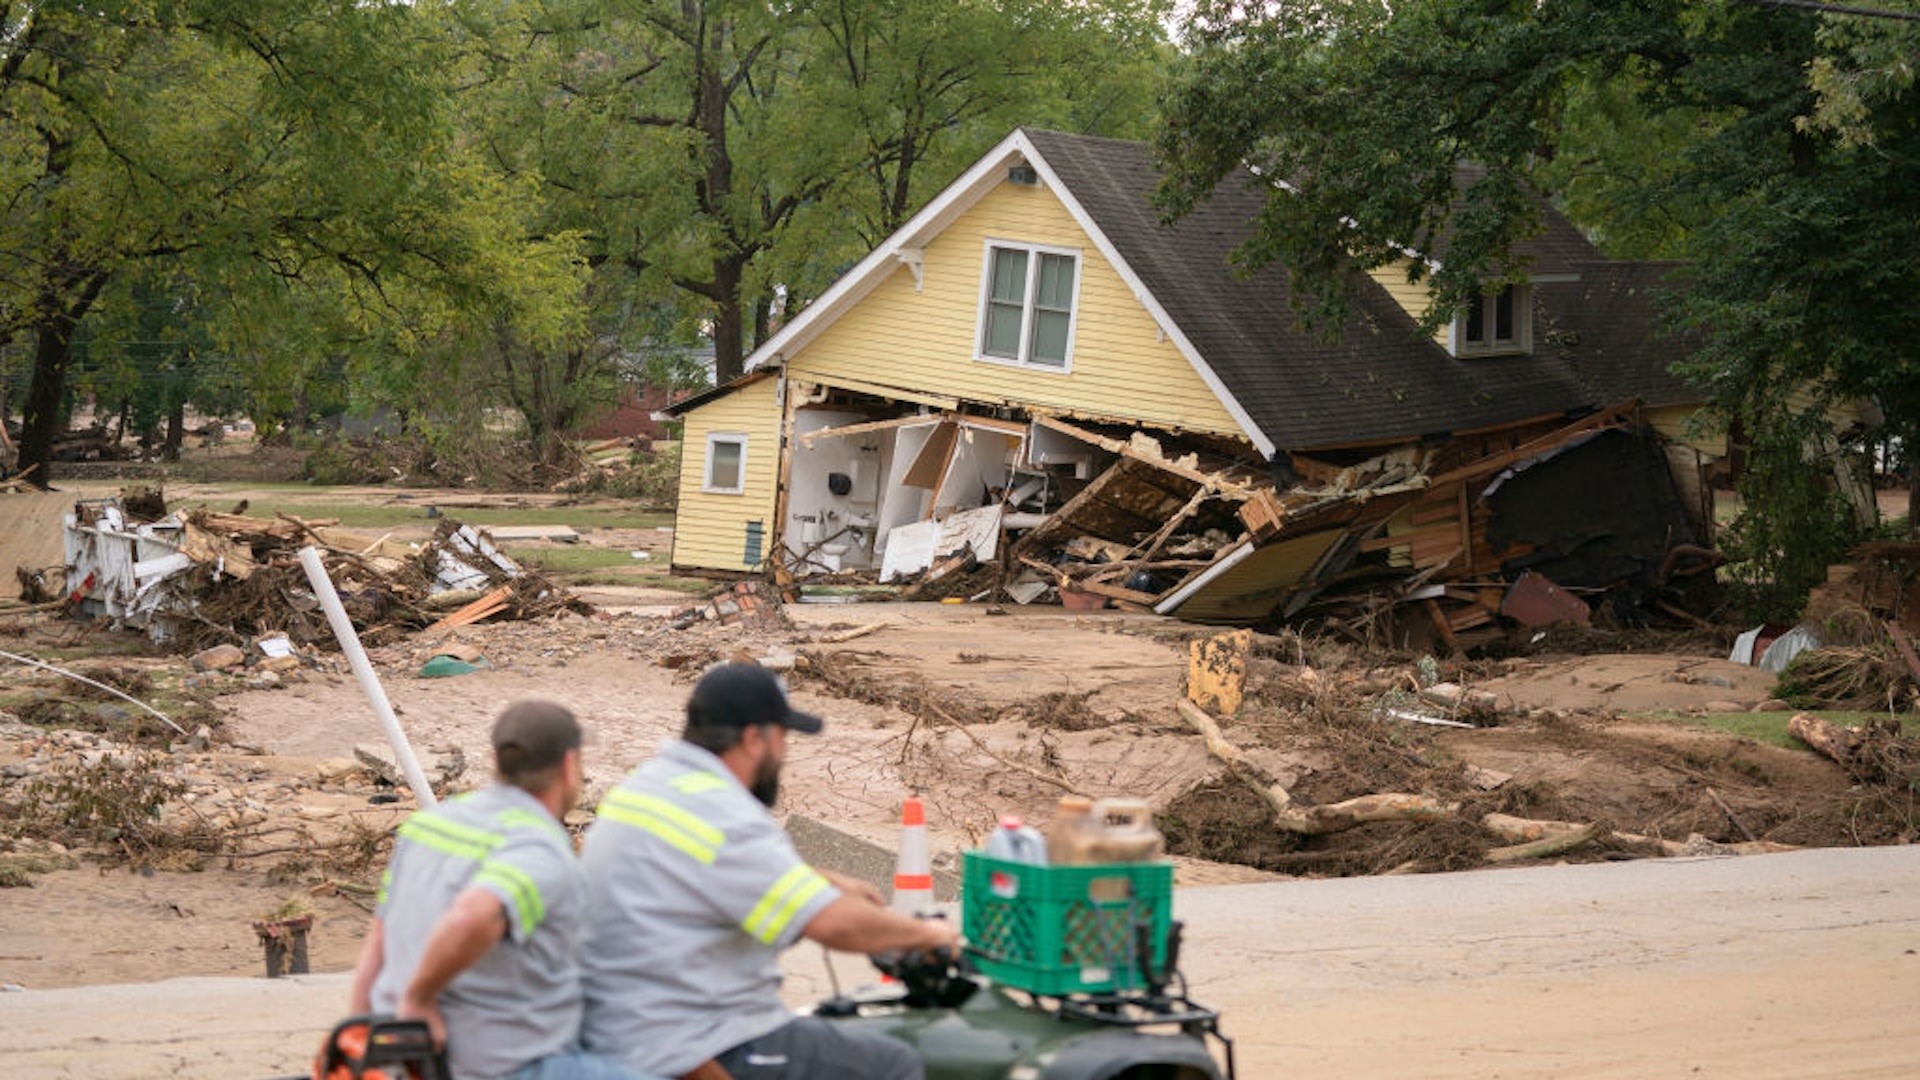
[372,784,588,1080]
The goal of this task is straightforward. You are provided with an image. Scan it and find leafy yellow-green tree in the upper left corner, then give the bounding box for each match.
[0,0,560,478]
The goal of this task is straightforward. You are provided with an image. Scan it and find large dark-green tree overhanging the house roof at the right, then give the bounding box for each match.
[1158,0,1920,615]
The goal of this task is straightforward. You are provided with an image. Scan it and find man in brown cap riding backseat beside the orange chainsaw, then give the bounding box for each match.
[351,701,636,1080]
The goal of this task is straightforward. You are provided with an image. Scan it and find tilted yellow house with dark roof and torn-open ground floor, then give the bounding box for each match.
[670,129,1712,599]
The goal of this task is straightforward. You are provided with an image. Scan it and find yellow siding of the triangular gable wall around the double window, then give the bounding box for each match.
[787,184,1240,434]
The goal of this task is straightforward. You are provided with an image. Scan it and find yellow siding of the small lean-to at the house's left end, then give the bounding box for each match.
[674,379,780,571]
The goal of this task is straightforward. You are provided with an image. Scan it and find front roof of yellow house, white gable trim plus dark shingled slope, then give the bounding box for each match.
[747,129,1697,455]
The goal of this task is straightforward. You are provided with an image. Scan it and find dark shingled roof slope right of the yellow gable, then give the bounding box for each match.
[1025,129,1689,450]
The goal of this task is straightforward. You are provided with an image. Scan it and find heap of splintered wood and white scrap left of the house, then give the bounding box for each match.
[58,490,588,650]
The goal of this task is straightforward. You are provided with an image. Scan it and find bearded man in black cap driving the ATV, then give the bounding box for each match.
[582,663,958,1080]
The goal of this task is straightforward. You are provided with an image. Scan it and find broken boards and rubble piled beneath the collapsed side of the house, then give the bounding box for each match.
[833,402,1720,651]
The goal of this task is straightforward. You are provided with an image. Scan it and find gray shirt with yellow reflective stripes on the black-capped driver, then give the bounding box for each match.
[580,740,841,1076]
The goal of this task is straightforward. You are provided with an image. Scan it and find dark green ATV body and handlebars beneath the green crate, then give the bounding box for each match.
[814,922,1235,1080]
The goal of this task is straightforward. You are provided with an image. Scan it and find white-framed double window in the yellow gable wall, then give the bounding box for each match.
[979,242,1079,371]
